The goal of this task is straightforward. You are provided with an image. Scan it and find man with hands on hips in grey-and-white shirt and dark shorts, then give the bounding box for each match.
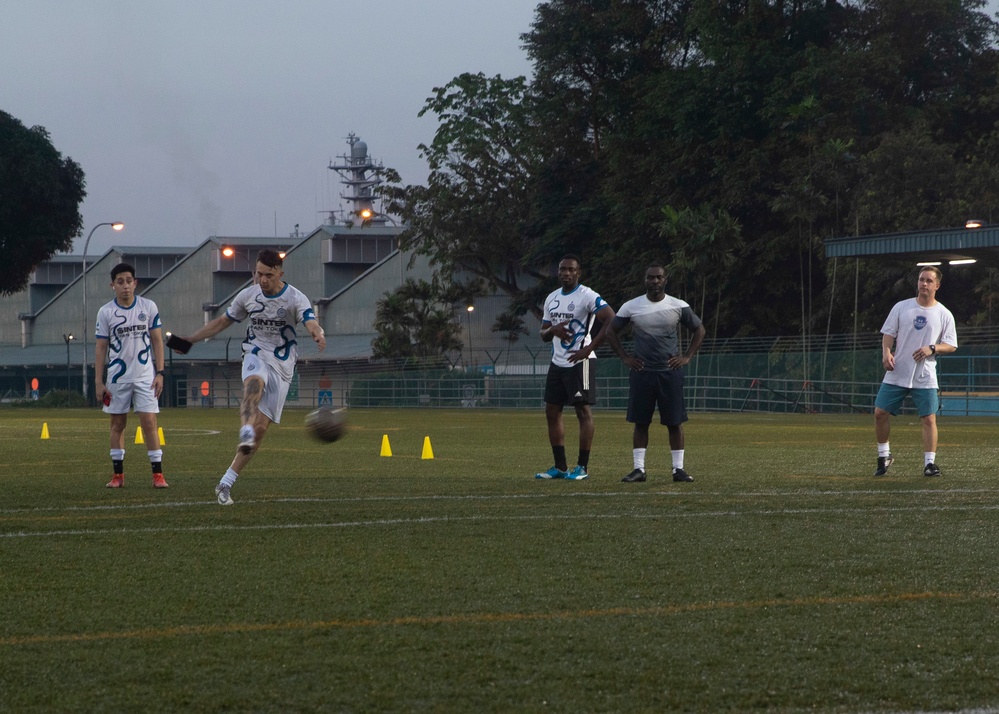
[607,263,705,483]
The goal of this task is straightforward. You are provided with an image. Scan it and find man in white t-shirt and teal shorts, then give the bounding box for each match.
[874,266,957,476]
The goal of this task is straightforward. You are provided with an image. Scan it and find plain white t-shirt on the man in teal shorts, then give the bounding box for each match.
[881,298,957,389]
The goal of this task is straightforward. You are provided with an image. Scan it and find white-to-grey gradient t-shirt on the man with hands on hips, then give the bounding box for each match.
[613,295,701,372]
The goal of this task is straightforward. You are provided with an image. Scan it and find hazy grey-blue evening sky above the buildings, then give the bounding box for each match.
[0,0,538,255]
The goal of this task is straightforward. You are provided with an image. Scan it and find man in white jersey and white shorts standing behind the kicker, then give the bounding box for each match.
[94,263,169,488]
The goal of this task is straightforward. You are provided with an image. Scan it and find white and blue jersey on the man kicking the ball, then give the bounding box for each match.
[225,283,316,382]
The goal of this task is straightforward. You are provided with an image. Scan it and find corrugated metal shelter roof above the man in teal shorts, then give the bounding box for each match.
[825,225,999,266]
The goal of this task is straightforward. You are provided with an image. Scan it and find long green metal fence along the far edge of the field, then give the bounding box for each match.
[162,351,999,416]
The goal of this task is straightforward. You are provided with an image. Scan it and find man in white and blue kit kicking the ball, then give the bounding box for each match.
[176,250,326,506]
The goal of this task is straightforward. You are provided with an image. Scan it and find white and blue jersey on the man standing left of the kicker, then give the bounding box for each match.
[94,295,162,384]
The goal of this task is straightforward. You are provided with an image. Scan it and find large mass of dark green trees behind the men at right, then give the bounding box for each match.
[395,0,999,337]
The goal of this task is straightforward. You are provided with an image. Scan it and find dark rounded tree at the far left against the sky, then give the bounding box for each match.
[0,111,87,295]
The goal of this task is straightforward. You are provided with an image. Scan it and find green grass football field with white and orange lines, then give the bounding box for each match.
[0,409,999,712]
